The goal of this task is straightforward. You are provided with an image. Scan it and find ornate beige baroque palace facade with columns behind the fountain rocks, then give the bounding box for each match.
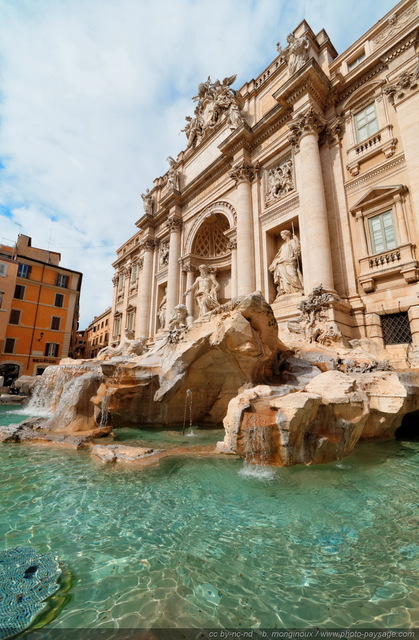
[111,0,419,368]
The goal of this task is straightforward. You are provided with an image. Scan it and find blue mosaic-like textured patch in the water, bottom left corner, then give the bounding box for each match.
[0,547,61,640]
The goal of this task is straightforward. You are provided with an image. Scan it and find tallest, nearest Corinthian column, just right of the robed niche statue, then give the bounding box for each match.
[289,108,334,294]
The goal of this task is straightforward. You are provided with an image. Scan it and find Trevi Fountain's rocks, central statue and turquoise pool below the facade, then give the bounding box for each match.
[0,292,419,638]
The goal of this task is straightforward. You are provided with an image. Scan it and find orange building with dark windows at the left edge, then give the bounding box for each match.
[0,235,82,382]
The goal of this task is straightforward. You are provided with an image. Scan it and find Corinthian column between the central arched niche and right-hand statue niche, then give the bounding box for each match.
[230,160,257,296]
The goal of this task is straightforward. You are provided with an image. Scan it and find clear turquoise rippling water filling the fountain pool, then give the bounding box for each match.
[0,408,419,628]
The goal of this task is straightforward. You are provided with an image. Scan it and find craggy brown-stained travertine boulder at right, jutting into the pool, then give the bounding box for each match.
[217,371,419,466]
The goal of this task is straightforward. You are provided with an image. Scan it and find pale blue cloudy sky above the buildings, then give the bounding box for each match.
[0,0,395,328]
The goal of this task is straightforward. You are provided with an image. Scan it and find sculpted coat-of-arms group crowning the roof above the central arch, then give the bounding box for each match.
[182,75,244,149]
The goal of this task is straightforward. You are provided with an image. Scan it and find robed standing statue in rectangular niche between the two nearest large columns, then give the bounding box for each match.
[269,229,304,299]
